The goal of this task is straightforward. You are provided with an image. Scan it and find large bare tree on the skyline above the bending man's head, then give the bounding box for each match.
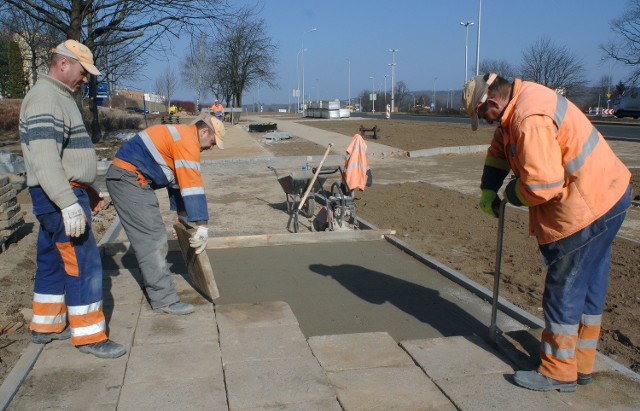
[212,12,278,111]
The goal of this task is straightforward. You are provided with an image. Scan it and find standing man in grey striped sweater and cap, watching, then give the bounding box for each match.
[20,40,127,358]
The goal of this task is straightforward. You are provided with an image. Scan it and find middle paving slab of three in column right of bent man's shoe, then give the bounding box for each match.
[220,325,313,365]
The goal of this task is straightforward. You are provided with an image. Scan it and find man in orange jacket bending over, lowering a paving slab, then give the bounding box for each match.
[106,114,225,315]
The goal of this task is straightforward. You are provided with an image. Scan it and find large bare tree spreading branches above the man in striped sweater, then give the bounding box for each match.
[4,0,242,141]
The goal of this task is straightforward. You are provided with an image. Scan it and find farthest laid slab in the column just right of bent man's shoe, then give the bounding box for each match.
[215,301,298,331]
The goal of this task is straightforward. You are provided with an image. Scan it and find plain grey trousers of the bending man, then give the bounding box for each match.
[105,165,180,308]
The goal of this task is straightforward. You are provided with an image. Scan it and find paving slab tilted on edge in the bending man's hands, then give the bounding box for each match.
[173,223,220,301]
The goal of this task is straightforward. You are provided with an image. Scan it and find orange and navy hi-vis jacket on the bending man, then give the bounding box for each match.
[113,124,209,221]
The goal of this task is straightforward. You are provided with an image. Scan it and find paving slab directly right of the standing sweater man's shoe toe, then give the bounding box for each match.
[125,342,223,384]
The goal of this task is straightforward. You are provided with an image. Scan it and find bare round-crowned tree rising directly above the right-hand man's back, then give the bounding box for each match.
[522,37,586,95]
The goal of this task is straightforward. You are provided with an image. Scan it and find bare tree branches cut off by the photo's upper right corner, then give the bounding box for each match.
[600,0,640,86]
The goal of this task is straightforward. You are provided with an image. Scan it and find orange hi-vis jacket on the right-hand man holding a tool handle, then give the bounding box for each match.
[485,79,631,244]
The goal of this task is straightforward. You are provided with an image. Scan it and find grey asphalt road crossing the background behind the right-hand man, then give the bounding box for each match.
[351,113,640,141]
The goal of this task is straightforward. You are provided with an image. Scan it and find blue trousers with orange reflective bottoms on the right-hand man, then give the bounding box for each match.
[538,187,631,381]
